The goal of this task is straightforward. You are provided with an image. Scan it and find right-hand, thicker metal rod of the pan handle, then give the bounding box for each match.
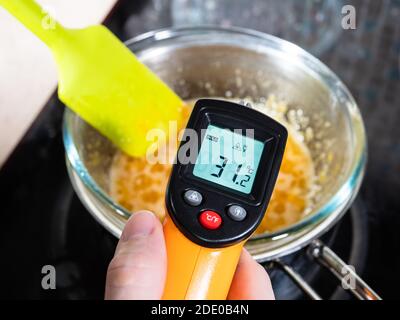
[308,240,382,300]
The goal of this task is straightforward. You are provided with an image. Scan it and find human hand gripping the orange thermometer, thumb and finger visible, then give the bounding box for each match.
[105,211,274,300]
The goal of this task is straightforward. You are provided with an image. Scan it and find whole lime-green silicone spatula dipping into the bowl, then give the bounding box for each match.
[0,0,184,156]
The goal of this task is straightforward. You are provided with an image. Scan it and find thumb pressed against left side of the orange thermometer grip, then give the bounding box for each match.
[105,211,167,300]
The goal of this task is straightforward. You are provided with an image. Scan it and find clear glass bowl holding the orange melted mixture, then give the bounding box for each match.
[63,27,367,261]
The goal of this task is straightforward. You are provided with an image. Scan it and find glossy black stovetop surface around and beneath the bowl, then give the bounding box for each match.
[0,0,400,299]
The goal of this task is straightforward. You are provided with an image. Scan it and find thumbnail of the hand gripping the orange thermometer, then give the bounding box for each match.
[121,211,156,240]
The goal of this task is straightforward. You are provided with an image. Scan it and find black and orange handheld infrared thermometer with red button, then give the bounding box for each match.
[163,99,288,300]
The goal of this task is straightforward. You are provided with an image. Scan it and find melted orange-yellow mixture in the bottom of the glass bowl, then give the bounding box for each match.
[110,97,314,234]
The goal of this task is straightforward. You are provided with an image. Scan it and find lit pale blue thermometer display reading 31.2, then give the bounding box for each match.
[193,125,264,194]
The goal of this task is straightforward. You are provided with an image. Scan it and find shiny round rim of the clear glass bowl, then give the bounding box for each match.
[63,25,367,241]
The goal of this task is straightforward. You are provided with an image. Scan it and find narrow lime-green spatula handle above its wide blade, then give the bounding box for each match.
[0,0,65,48]
